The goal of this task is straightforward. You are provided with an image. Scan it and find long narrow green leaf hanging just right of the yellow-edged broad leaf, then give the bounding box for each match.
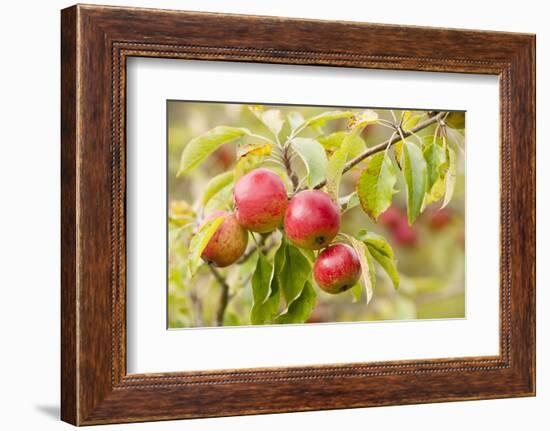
[403,141,428,225]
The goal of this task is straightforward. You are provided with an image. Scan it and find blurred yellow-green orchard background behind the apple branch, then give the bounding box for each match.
[168,101,465,328]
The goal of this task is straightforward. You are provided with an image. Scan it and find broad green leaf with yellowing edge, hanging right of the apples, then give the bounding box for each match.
[357,151,397,220]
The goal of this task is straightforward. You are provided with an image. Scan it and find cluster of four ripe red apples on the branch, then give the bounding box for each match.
[202,168,361,294]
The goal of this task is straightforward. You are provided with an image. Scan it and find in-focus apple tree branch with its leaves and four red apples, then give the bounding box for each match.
[174,106,464,325]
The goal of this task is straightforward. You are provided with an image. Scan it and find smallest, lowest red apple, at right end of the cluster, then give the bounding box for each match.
[313,244,361,294]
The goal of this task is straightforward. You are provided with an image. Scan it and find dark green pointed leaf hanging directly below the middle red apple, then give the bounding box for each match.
[279,243,311,306]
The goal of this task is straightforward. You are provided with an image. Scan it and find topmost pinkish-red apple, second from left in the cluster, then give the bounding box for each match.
[233,168,288,233]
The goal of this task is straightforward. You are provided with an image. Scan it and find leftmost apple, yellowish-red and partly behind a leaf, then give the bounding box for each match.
[201,211,248,268]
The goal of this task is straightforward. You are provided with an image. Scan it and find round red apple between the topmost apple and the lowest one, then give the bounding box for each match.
[285,190,340,250]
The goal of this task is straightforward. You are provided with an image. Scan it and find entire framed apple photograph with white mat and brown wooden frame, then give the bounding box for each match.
[61,5,535,425]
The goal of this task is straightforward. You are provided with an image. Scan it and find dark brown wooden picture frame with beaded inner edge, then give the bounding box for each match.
[61,5,535,425]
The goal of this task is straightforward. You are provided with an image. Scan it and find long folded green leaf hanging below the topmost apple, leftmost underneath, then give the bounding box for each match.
[250,248,284,325]
